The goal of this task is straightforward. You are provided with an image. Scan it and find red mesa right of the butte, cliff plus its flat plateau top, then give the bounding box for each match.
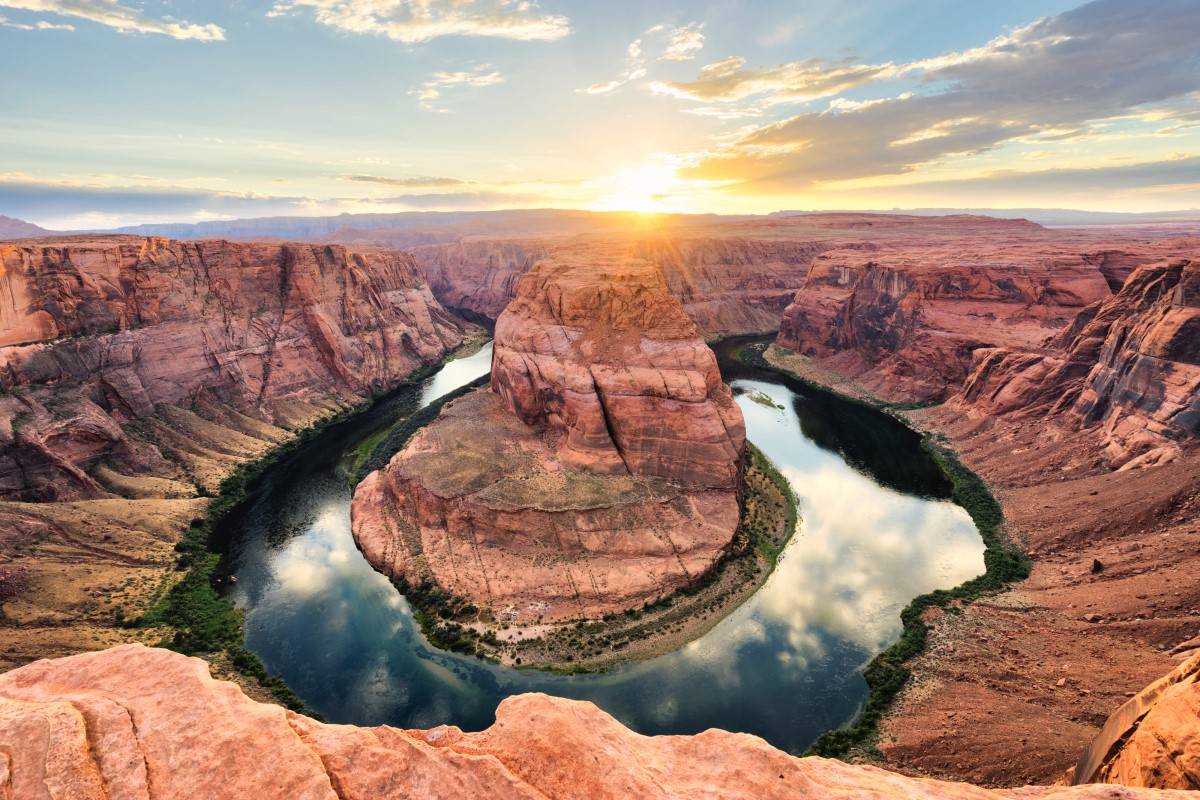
[778,217,1193,402]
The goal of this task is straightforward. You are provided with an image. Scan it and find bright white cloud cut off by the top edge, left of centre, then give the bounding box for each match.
[268,0,571,44]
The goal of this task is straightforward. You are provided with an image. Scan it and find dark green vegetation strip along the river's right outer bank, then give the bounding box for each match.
[737,342,1031,758]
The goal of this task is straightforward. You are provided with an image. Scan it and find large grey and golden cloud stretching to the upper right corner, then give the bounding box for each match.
[681,0,1200,192]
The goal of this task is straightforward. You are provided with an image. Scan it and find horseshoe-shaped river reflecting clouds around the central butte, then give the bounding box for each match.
[226,345,983,752]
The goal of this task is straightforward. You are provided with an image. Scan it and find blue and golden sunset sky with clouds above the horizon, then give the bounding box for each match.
[0,0,1200,229]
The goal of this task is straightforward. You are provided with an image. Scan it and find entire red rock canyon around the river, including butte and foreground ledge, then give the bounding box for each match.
[0,213,1200,799]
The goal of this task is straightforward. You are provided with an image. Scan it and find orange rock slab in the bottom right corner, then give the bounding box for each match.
[1074,640,1200,790]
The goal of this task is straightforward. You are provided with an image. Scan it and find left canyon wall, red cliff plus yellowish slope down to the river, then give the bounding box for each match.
[0,236,463,666]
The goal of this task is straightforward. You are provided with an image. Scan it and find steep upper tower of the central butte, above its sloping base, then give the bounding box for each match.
[492,249,745,488]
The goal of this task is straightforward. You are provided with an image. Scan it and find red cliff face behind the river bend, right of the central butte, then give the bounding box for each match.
[779,246,1109,401]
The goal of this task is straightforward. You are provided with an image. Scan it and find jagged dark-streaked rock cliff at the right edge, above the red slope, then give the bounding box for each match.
[955,259,1200,467]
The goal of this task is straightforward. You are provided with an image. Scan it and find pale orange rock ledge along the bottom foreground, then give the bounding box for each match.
[0,644,1192,800]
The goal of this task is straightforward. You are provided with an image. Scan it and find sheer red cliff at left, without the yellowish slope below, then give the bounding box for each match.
[0,236,461,500]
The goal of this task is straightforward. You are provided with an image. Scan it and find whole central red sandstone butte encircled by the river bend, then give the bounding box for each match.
[352,248,745,625]
